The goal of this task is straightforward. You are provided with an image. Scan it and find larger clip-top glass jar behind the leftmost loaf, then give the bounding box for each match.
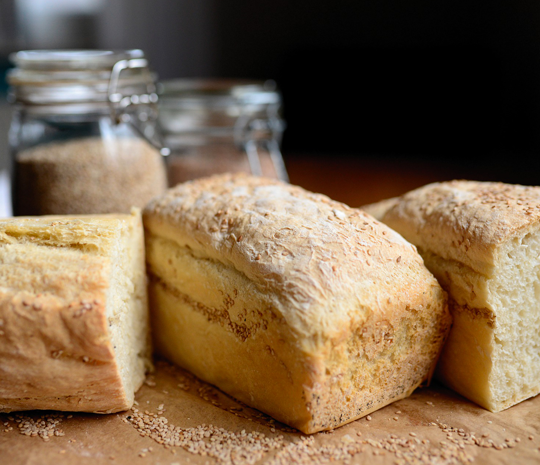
[8,50,167,215]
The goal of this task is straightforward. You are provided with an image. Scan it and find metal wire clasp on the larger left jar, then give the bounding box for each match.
[107,58,158,124]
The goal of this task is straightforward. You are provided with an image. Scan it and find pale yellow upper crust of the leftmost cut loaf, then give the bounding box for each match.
[0,209,139,302]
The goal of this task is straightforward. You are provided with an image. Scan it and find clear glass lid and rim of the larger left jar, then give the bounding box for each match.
[8,50,157,116]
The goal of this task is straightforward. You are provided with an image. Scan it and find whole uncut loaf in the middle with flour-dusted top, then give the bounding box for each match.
[143,175,450,433]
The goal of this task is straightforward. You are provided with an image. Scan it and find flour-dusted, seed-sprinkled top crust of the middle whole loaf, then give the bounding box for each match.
[143,174,441,338]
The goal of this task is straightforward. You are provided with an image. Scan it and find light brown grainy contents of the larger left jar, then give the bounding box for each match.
[15,137,167,215]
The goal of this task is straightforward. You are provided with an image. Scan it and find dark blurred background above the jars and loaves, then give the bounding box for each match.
[0,0,540,184]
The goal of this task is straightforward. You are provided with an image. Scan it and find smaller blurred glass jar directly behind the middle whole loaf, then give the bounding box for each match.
[158,79,288,186]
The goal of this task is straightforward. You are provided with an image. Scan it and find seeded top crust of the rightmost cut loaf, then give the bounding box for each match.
[376,180,540,275]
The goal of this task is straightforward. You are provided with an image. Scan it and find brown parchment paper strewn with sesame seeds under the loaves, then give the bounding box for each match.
[0,361,540,465]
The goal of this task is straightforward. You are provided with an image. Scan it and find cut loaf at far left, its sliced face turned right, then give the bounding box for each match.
[0,210,151,413]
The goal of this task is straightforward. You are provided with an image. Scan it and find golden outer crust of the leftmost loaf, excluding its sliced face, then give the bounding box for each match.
[0,213,149,413]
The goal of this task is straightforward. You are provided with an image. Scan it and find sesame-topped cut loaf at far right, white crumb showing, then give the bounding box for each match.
[366,181,540,412]
